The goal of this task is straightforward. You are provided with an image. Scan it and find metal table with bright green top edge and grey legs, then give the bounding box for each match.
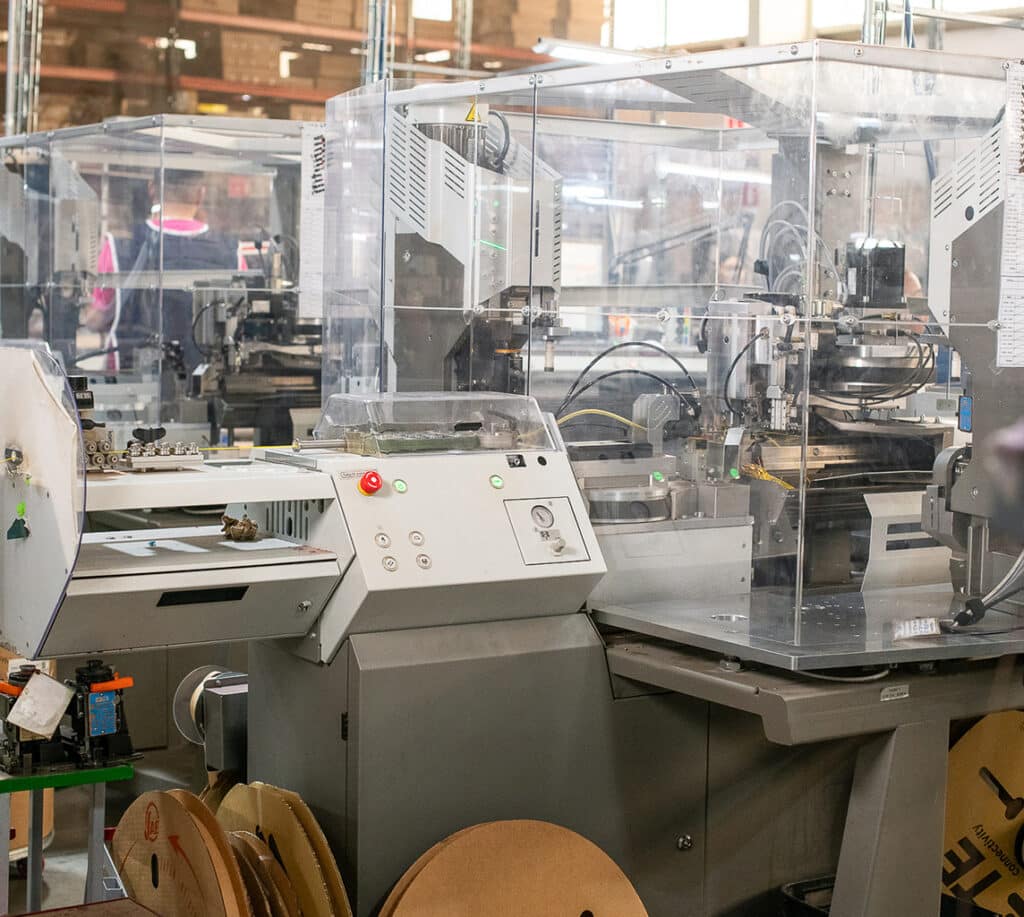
[0,765,135,915]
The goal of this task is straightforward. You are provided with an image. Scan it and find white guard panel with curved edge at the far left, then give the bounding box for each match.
[0,341,85,658]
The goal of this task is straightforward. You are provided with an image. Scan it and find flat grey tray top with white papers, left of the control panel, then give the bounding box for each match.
[75,526,335,579]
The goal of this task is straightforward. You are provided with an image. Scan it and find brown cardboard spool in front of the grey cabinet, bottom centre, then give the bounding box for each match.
[393,821,647,917]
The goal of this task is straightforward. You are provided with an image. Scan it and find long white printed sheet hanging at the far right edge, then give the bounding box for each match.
[995,61,1024,368]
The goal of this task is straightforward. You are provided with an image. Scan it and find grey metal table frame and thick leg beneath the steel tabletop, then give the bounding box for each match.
[606,634,1024,917]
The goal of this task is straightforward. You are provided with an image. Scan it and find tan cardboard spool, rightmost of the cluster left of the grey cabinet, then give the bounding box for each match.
[217,783,335,917]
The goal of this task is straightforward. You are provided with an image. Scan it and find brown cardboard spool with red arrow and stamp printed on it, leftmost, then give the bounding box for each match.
[114,791,238,917]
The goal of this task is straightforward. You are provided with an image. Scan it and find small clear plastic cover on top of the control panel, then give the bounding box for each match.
[314,392,553,455]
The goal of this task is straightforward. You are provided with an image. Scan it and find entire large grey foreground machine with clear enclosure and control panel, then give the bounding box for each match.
[6,42,1024,917]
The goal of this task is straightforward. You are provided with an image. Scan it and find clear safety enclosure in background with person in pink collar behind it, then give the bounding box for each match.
[0,116,323,448]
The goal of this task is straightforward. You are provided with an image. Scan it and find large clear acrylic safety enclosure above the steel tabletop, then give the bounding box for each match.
[325,42,1024,668]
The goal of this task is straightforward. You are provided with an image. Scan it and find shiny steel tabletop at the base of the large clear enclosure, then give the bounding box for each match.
[593,587,1024,671]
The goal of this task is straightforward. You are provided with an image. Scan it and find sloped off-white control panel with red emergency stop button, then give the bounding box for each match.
[292,449,605,659]
